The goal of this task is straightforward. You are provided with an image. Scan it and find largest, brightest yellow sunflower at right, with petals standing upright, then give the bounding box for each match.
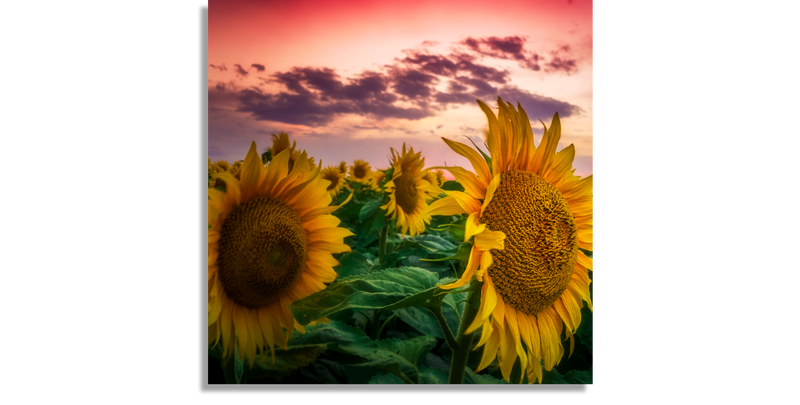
[428,98,595,383]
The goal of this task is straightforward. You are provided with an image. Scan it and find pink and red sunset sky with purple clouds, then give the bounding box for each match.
[207,0,595,179]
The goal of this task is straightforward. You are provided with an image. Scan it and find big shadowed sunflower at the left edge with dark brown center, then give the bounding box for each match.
[208,142,353,367]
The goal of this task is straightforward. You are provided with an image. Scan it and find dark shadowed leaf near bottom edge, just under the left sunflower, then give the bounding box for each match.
[244,344,327,380]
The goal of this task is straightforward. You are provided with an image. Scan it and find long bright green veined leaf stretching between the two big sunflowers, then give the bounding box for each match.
[290,267,439,325]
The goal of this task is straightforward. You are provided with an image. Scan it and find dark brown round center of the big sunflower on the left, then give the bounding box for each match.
[218,197,307,308]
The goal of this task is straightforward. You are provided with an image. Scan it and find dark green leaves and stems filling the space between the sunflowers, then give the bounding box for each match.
[208,175,596,386]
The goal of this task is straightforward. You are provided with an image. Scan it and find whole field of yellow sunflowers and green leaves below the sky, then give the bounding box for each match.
[208,99,595,387]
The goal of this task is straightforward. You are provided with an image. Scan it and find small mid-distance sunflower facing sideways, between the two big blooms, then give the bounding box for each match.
[381,143,442,236]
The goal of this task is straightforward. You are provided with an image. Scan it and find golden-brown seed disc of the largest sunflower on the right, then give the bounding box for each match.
[480,170,578,315]
